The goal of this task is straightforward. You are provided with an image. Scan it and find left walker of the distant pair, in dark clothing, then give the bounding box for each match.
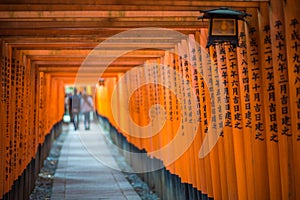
[69,88,81,130]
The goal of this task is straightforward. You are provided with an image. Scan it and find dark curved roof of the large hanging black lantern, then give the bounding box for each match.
[198,7,251,20]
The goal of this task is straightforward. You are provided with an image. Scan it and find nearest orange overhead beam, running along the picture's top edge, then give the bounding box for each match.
[0,0,269,11]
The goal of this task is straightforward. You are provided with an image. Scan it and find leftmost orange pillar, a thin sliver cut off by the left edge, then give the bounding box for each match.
[0,40,7,198]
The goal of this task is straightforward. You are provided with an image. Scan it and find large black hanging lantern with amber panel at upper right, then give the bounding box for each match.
[198,7,251,47]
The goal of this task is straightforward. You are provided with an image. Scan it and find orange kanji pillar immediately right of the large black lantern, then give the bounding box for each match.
[237,22,254,199]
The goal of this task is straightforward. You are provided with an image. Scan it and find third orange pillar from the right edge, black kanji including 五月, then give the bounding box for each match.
[259,4,281,199]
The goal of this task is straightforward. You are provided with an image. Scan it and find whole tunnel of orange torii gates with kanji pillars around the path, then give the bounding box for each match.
[0,0,300,200]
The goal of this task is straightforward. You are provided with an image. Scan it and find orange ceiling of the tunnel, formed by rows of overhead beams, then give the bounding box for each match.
[0,0,262,82]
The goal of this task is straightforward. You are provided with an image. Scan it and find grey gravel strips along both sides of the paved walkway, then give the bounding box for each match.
[30,125,159,200]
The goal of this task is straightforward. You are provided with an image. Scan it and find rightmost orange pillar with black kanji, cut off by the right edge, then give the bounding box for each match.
[284,0,300,199]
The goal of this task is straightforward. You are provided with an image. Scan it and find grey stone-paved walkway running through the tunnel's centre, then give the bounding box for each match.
[51,123,140,200]
